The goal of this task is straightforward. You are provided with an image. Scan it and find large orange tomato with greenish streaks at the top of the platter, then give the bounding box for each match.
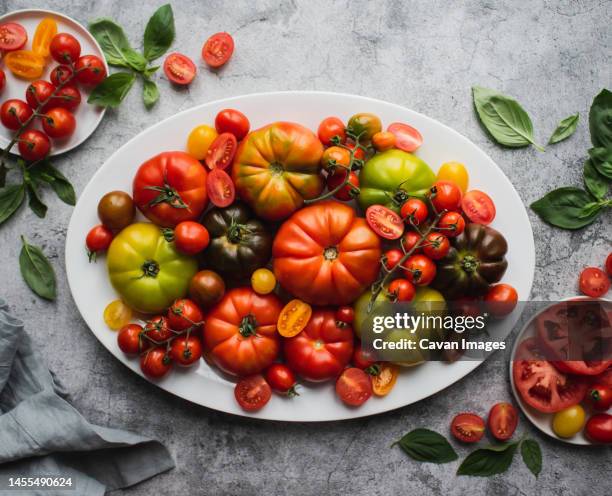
[232,122,324,220]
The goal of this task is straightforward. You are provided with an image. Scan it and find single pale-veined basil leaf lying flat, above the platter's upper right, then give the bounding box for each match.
[472,86,543,150]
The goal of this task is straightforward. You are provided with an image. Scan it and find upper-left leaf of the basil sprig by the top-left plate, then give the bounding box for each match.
[89,18,147,72]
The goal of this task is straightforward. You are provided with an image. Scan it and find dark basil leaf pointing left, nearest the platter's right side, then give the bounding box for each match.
[531,187,599,229]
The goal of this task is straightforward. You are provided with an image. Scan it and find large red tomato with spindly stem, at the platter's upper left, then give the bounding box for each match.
[133,152,208,227]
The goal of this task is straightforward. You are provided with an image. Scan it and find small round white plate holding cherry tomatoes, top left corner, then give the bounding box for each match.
[0,9,108,156]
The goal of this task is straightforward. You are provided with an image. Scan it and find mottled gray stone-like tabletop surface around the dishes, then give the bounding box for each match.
[0,0,612,495]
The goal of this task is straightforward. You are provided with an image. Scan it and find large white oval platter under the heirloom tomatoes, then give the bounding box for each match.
[66,91,535,421]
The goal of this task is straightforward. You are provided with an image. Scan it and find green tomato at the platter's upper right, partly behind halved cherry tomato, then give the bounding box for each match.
[359,150,436,212]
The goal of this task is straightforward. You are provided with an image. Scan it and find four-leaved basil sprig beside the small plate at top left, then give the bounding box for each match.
[87,4,175,109]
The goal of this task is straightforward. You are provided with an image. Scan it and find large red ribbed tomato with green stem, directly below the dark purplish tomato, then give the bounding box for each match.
[204,287,283,376]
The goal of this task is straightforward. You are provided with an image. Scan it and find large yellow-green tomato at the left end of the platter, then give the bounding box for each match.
[106,222,198,313]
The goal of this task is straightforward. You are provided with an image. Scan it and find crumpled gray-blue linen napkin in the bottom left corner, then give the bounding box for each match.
[0,298,174,496]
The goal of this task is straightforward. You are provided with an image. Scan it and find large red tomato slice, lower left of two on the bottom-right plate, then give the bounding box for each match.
[512,338,588,413]
